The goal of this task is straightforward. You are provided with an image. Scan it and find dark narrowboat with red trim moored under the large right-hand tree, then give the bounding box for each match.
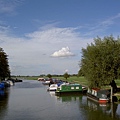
[87,88,110,103]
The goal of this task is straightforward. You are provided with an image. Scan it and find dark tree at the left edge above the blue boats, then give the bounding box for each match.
[0,48,10,80]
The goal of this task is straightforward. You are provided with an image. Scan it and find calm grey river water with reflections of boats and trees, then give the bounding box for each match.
[0,80,120,120]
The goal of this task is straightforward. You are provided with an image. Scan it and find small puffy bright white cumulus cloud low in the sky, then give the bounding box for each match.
[51,47,75,57]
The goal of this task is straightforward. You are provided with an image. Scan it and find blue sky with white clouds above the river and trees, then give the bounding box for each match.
[0,0,120,76]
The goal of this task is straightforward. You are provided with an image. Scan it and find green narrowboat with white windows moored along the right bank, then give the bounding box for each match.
[55,84,87,95]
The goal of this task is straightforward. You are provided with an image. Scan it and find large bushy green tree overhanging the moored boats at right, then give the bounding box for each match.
[80,36,120,87]
